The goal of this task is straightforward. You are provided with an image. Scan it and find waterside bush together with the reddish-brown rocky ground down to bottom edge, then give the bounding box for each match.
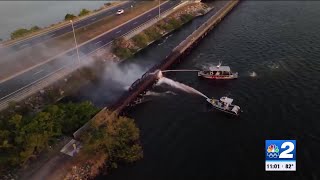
[64,111,143,180]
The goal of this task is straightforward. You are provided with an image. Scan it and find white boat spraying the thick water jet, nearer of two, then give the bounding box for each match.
[207,96,241,116]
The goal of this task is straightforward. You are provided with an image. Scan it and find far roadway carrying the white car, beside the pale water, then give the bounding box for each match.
[0,1,136,51]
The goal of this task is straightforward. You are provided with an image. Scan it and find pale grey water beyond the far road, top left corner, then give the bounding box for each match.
[0,1,105,39]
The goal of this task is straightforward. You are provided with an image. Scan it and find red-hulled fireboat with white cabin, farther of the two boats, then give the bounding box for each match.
[198,63,238,79]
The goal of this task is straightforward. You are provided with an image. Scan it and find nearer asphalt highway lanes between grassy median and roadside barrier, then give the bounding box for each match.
[0,1,180,100]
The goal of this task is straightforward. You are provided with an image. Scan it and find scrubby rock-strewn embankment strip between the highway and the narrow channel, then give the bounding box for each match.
[112,4,207,59]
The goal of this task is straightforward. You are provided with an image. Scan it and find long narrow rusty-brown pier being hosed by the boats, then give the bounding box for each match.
[73,0,239,139]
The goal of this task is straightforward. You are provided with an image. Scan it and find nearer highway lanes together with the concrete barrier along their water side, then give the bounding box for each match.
[0,1,180,109]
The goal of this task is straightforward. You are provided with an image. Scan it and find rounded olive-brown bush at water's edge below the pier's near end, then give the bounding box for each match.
[82,112,143,166]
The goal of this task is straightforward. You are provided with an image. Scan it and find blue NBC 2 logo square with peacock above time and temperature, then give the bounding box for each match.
[266,140,296,161]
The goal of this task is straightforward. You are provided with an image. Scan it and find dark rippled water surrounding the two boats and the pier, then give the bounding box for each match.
[68,1,320,180]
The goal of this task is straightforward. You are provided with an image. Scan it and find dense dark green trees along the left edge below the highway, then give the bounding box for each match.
[0,102,98,169]
